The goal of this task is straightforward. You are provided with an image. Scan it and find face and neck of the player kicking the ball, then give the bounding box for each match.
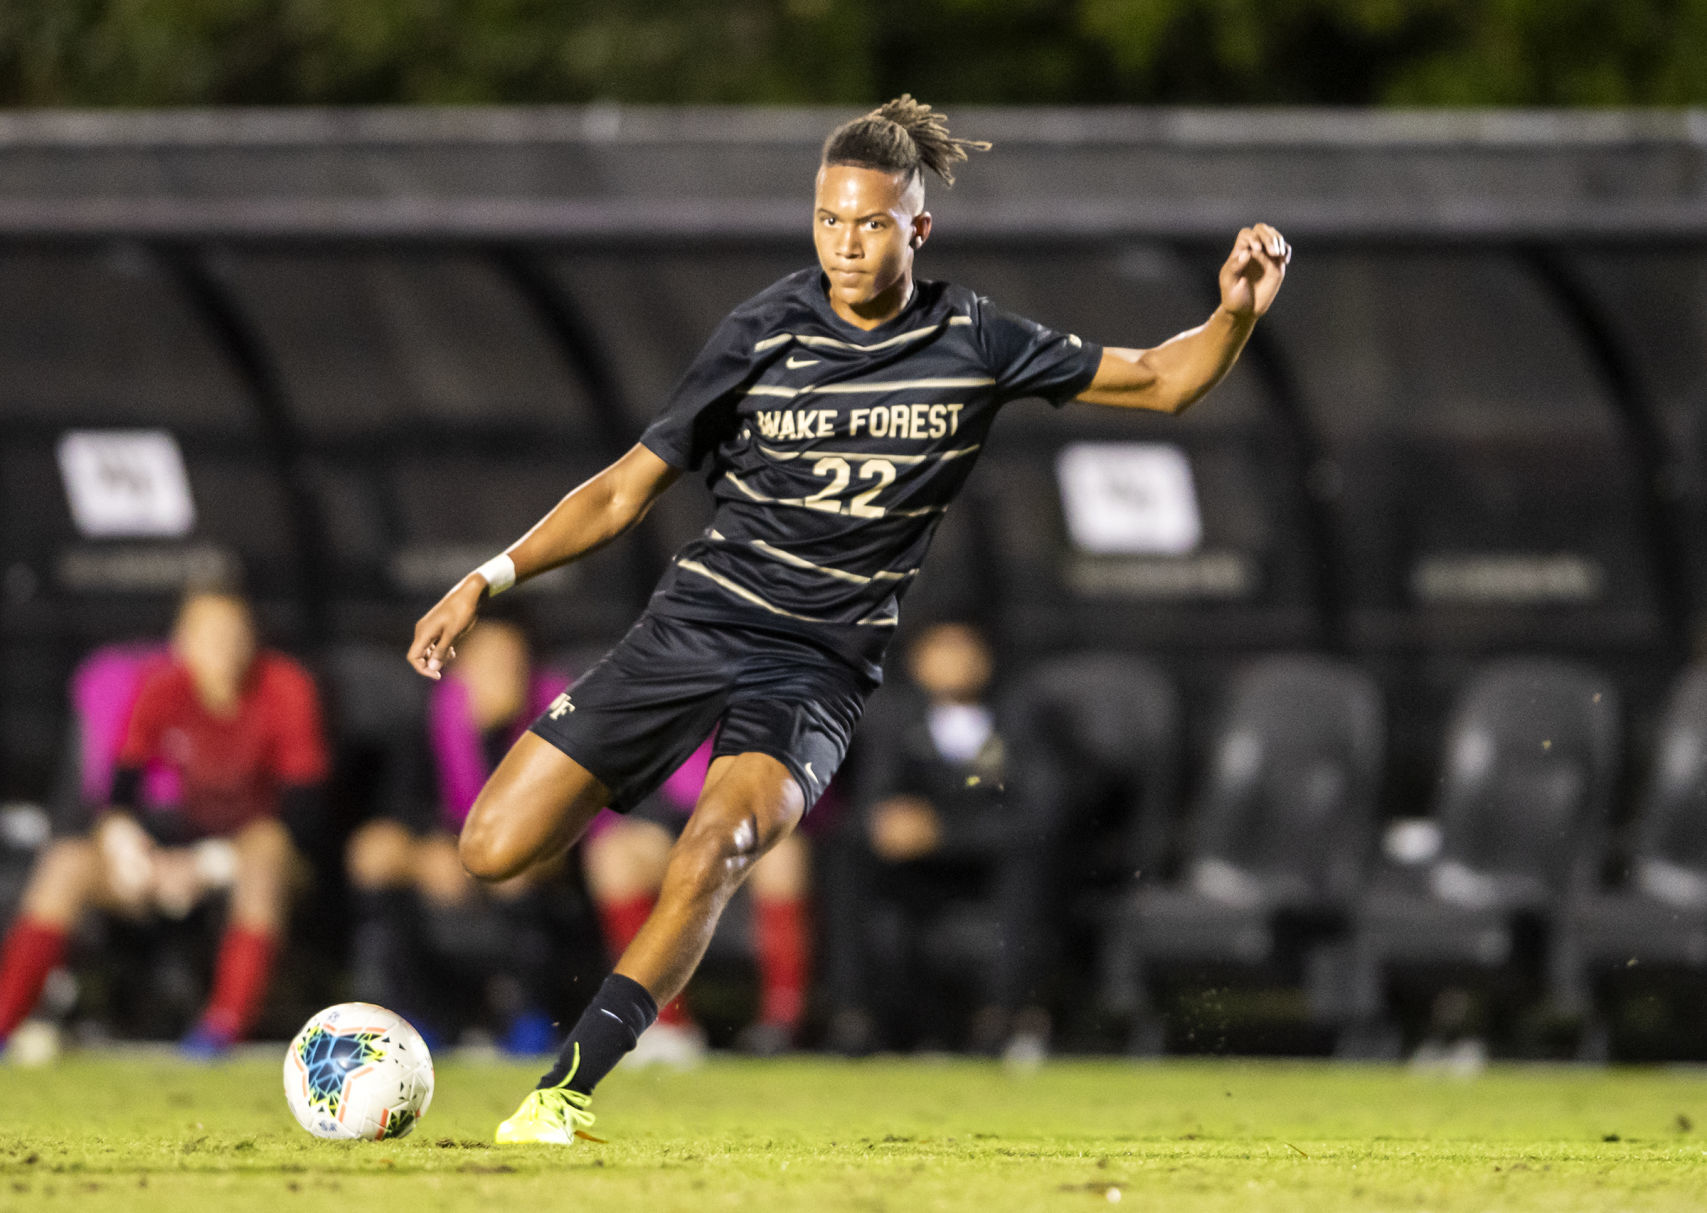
[813,164,930,326]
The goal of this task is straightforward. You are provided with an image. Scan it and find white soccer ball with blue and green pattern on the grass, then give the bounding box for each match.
[285,1003,432,1141]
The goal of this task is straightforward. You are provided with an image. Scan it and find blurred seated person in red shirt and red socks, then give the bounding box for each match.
[0,590,328,1056]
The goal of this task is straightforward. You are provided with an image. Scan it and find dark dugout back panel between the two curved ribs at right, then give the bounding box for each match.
[1265,249,1675,814]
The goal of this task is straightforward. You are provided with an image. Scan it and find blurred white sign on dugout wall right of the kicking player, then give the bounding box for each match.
[1055,442,1203,556]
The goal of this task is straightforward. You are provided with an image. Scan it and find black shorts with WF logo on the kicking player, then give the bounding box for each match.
[533,611,877,812]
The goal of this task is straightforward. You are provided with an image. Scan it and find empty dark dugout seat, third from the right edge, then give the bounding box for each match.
[1108,655,1384,1048]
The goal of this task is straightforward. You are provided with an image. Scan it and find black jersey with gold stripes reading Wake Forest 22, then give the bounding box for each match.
[640,270,1101,672]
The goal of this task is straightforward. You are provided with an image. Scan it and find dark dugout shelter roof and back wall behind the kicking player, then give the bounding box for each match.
[0,107,1707,815]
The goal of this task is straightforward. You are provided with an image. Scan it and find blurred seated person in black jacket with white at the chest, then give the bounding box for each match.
[824,621,1053,1061]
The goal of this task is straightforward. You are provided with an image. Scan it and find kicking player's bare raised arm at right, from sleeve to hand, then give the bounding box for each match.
[1075,223,1292,413]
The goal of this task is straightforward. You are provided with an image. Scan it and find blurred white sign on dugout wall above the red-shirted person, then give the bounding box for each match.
[60,430,196,539]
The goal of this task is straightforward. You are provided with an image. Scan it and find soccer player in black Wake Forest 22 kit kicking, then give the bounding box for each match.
[408,96,1290,1145]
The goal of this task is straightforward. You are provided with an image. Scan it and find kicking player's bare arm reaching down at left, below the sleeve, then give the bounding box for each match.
[408,444,681,679]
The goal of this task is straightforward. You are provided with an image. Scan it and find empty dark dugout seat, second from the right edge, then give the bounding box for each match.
[1352,659,1622,1041]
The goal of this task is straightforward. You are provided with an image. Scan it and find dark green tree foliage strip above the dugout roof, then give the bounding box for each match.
[0,0,1707,106]
